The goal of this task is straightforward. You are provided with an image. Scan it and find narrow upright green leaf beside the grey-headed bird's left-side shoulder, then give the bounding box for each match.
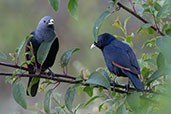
[15,34,33,58]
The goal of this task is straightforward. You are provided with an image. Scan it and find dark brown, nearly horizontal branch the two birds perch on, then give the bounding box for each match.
[0,62,158,94]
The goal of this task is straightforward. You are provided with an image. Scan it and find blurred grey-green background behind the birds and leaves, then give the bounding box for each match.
[0,0,150,114]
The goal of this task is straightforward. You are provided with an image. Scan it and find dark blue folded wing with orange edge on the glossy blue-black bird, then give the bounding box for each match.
[104,41,140,74]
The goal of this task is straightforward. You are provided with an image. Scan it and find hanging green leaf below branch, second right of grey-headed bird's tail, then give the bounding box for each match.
[64,87,75,113]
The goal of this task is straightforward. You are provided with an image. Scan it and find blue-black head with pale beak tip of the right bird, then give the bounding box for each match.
[91,33,115,49]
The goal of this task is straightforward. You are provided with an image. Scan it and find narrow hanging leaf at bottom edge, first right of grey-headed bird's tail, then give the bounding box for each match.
[44,89,53,114]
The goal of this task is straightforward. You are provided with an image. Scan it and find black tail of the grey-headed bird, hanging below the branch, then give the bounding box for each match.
[27,73,40,97]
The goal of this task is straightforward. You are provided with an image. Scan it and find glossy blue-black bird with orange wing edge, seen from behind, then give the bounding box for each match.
[91,33,144,91]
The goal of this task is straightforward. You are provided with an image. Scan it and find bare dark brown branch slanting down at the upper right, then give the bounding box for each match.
[113,0,164,36]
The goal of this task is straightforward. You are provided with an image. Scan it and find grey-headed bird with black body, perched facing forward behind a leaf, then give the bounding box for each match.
[25,16,59,97]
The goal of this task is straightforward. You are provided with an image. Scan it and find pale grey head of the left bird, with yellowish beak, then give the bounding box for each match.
[37,16,54,30]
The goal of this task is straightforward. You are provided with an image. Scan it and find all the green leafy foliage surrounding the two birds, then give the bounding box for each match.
[0,0,171,114]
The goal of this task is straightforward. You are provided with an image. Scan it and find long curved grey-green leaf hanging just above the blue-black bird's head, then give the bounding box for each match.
[93,10,111,41]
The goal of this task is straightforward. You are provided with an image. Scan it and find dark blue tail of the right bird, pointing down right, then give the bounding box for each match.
[123,70,144,91]
